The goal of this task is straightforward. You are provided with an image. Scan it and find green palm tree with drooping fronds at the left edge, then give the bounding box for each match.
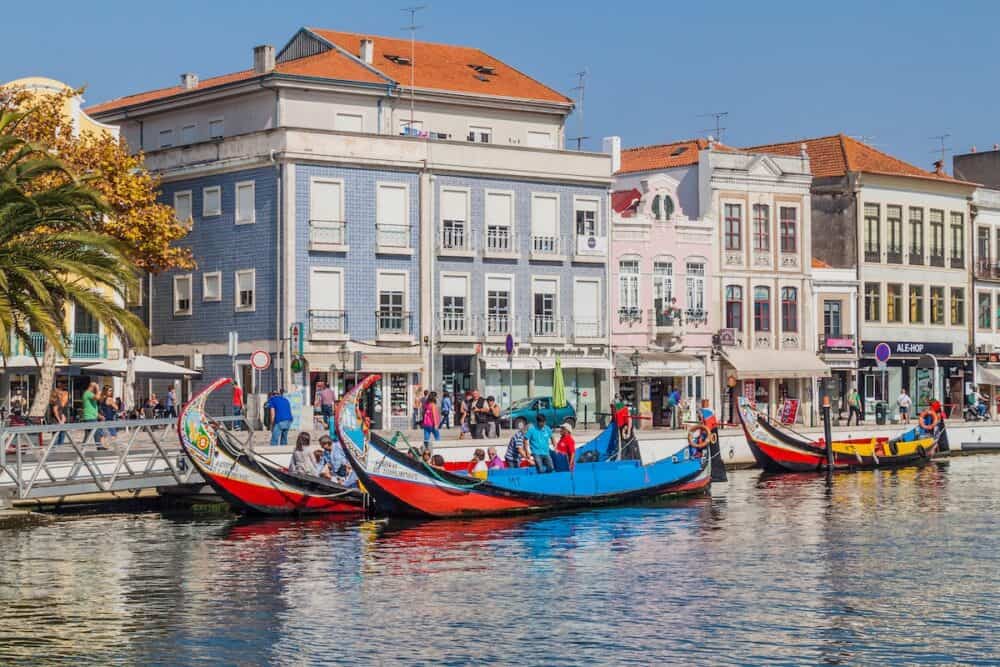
[0,112,148,417]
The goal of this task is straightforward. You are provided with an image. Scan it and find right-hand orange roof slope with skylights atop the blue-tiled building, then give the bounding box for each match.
[309,28,572,104]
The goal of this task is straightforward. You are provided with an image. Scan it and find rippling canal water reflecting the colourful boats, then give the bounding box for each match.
[0,456,1000,665]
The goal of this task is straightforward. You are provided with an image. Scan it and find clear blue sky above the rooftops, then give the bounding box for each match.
[0,0,1000,169]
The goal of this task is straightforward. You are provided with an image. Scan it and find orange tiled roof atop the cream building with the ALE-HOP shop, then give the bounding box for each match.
[746,134,961,182]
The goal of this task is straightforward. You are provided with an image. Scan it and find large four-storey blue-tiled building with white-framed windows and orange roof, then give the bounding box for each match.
[93,29,611,422]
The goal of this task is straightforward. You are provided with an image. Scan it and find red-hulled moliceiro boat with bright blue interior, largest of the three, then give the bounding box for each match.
[336,376,712,517]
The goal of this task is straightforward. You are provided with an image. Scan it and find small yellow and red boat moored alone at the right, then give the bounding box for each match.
[738,397,944,472]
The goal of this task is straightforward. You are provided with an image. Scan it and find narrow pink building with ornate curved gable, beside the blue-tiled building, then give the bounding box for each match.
[608,138,719,426]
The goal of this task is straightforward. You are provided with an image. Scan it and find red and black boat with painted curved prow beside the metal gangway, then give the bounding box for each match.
[177,378,364,514]
